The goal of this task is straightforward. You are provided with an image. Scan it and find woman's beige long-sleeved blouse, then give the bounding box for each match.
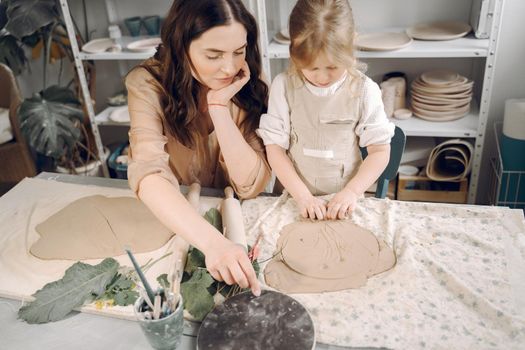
[126,63,271,198]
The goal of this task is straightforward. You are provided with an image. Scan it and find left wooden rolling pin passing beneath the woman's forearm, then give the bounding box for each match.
[168,183,201,305]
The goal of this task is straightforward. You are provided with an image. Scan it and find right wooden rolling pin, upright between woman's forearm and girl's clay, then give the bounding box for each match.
[221,186,248,251]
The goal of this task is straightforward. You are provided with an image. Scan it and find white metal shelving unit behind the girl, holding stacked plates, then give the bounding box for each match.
[256,0,504,203]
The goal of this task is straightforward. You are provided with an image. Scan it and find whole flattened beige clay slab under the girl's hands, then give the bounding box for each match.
[264,221,395,293]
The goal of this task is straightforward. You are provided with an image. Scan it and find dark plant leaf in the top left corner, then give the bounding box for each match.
[6,0,59,39]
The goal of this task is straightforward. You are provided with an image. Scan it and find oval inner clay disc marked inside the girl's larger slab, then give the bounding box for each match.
[277,220,379,279]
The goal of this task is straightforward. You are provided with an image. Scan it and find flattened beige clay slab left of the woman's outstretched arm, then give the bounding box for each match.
[30,195,173,260]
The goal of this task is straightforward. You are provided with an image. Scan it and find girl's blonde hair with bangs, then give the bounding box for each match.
[289,0,360,77]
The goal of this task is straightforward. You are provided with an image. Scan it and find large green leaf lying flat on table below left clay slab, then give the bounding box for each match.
[18,258,119,323]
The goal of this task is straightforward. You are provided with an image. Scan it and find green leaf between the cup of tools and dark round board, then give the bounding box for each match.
[181,269,215,320]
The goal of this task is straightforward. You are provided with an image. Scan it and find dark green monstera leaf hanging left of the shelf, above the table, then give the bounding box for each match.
[18,86,84,160]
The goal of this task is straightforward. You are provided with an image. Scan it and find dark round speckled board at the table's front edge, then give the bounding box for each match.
[197,290,315,350]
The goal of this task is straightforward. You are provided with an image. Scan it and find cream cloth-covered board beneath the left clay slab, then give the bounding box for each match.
[0,178,220,319]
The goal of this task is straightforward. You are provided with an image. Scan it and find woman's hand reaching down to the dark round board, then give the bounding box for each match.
[204,237,261,296]
